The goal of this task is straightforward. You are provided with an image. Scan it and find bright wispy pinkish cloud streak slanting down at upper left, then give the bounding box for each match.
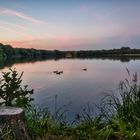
[0,9,47,24]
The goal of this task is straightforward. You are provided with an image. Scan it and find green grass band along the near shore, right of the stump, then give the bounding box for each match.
[0,70,140,140]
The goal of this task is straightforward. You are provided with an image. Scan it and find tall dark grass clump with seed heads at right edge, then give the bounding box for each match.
[110,71,140,128]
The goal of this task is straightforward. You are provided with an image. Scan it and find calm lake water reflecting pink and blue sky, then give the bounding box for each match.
[0,59,140,116]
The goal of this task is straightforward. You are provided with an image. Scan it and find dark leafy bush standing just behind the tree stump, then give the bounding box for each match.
[0,69,33,107]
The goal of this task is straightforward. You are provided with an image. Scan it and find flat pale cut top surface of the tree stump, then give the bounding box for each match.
[0,106,23,116]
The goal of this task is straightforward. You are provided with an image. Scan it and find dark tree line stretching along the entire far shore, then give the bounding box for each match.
[0,43,140,60]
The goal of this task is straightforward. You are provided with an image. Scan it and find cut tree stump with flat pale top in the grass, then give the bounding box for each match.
[0,107,30,140]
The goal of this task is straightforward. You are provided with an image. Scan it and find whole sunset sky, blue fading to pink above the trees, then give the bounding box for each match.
[0,0,140,50]
